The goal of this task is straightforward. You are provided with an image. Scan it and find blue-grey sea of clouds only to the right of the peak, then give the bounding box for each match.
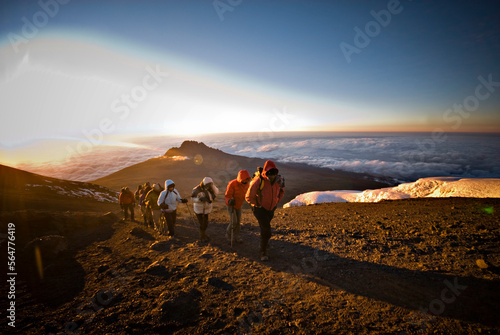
[201,134,500,182]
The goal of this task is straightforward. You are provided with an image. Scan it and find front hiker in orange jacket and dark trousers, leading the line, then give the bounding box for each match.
[245,161,285,261]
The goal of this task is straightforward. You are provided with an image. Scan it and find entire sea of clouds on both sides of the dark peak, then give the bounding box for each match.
[16,133,500,182]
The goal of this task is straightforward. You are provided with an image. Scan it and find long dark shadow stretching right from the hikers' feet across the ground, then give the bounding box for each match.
[189,223,500,327]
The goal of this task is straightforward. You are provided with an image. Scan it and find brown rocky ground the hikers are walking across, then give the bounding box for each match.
[0,198,500,334]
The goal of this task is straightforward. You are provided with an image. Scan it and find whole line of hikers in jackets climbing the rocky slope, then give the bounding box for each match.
[119,160,285,261]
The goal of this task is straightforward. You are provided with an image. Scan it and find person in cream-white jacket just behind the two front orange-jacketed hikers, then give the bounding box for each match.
[191,177,219,242]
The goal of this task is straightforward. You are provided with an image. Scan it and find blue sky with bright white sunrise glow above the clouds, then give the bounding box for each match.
[0,0,500,163]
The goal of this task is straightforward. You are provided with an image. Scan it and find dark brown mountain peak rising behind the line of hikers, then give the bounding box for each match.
[92,141,392,201]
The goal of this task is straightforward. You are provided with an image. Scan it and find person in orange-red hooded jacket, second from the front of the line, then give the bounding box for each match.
[225,170,251,243]
